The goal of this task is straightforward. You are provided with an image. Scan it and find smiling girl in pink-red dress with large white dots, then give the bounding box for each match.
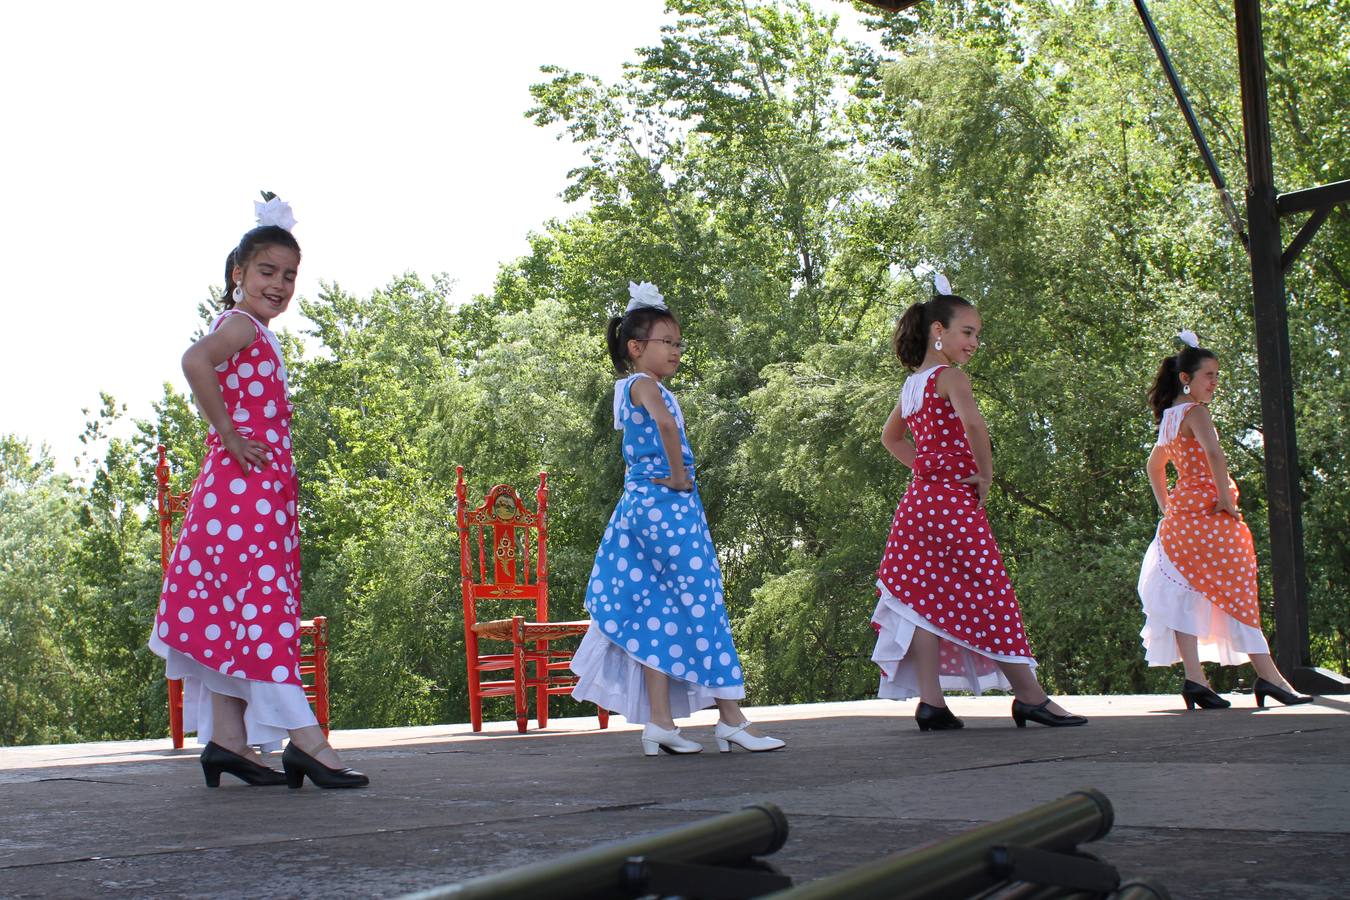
[150,196,367,788]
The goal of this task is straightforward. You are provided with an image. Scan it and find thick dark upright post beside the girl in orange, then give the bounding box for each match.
[1234,0,1311,685]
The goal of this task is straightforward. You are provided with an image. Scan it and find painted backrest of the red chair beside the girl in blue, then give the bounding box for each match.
[455,466,548,630]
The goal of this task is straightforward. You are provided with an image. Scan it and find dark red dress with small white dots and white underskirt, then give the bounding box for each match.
[872,366,1035,700]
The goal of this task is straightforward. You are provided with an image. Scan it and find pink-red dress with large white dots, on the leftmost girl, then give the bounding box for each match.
[150,309,316,746]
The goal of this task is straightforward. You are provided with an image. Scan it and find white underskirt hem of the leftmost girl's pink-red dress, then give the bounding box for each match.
[150,634,319,752]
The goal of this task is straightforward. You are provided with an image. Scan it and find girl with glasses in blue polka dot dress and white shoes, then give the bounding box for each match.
[572,282,783,756]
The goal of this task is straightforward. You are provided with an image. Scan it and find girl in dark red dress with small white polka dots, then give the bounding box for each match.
[872,282,1087,731]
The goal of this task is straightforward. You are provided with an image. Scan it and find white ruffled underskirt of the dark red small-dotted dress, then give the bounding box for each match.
[872,580,1035,700]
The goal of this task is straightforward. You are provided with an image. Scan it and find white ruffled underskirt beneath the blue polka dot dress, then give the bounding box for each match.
[571,622,745,725]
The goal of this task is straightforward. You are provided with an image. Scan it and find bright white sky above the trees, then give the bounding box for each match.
[0,0,855,471]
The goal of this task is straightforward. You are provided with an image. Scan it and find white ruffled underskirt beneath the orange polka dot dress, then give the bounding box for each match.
[1139,537,1270,667]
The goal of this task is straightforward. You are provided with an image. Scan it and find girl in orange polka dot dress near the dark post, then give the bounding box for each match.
[1139,332,1312,710]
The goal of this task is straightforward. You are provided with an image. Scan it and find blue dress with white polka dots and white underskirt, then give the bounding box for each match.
[571,375,745,725]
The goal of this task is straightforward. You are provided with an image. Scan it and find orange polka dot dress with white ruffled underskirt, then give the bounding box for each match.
[1139,403,1270,665]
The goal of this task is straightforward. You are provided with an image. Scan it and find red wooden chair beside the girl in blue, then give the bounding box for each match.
[455,466,609,733]
